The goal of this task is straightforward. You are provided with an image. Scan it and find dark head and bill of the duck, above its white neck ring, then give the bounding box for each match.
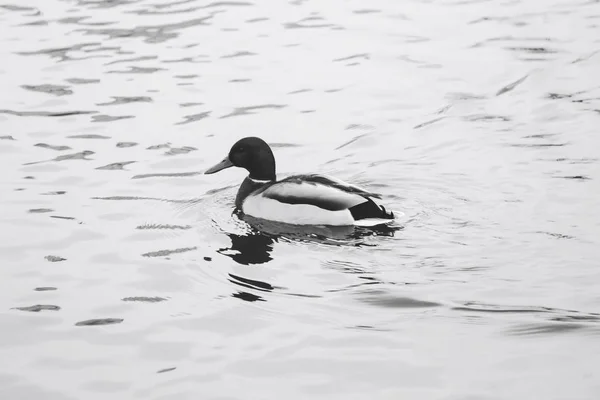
[204,137,275,181]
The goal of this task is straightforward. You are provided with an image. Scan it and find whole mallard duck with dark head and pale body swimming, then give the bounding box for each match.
[204,137,395,226]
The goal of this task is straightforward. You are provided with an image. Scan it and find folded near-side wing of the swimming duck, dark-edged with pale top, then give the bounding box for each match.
[254,175,379,211]
